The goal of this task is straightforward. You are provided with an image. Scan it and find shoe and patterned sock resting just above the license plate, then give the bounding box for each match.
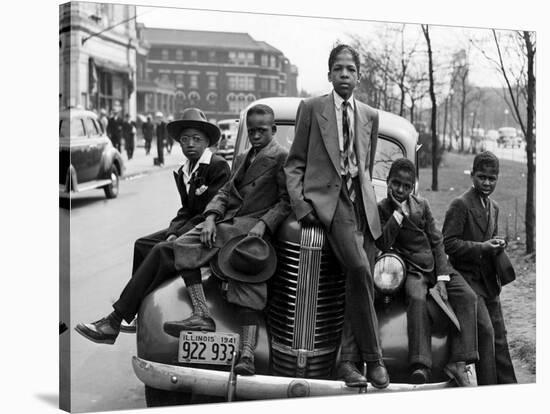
[163,283,216,338]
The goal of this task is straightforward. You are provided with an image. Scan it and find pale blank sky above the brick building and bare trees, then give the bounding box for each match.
[137,7,520,95]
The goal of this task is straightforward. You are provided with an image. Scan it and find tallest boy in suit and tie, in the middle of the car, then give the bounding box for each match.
[285,45,389,388]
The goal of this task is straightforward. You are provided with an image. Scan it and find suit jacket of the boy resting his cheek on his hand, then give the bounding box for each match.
[376,195,455,284]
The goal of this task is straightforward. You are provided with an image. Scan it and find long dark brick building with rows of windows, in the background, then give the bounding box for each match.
[137,25,298,121]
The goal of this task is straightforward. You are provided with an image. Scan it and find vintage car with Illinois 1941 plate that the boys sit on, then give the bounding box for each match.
[133,98,451,405]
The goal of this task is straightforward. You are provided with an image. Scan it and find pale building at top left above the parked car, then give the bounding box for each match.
[59,2,139,118]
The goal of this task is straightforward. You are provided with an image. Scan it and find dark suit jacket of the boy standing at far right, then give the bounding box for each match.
[443,187,500,298]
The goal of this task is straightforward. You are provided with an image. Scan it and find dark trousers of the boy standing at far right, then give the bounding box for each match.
[476,294,517,385]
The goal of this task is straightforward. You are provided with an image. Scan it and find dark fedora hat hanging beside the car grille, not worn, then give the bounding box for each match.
[212,235,277,283]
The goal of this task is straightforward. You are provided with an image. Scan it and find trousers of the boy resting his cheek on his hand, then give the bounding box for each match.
[405,273,478,368]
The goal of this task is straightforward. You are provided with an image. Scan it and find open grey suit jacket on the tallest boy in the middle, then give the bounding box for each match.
[285,94,381,239]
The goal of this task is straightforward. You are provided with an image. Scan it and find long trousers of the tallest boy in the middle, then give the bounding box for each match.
[327,179,382,362]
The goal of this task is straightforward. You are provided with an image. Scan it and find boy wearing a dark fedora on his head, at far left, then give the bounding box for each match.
[76,108,230,336]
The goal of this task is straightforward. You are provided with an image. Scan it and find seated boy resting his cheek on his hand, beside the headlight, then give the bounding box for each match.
[376,158,478,386]
